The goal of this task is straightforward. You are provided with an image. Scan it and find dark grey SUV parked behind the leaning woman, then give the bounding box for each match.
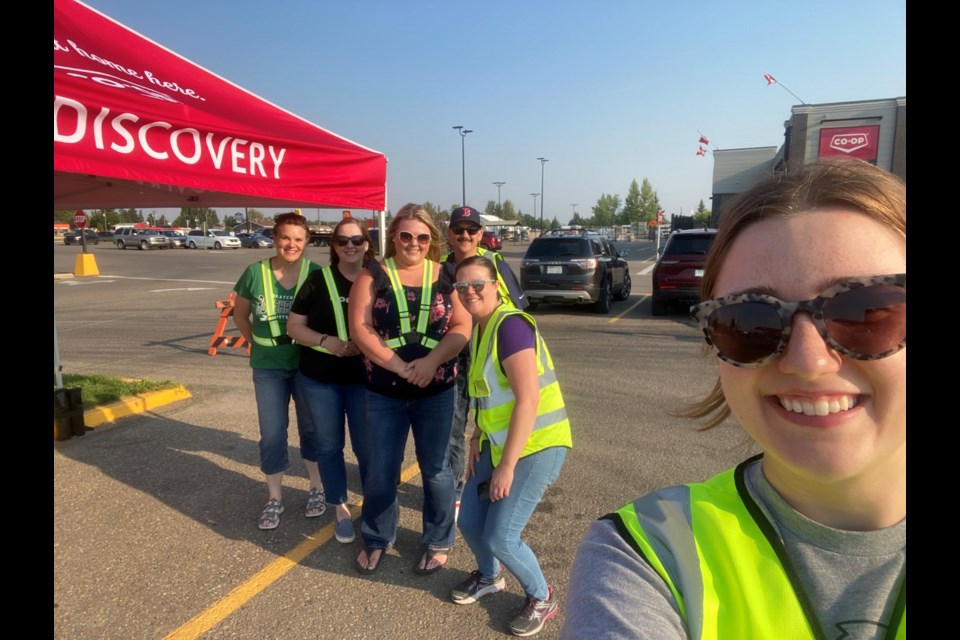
[520,234,631,313]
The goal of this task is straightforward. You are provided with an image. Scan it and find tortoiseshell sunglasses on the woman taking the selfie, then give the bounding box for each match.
[690,273,907,367]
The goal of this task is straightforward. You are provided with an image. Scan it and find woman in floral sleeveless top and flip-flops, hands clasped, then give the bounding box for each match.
[349,204,470,575]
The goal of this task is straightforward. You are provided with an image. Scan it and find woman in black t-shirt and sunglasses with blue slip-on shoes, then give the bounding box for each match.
[287,218,374,544]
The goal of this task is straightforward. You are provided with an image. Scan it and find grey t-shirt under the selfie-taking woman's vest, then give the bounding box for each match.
[560,461,907,640]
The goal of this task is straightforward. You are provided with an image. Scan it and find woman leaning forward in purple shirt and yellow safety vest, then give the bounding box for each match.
[450,256,573,636]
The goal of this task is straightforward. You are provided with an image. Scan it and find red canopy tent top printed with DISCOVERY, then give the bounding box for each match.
[53,0,387,211]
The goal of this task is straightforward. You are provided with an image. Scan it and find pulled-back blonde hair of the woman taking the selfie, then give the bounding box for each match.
[676,158,907,429]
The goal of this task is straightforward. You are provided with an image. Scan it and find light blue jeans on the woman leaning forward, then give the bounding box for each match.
[457,444,567,600]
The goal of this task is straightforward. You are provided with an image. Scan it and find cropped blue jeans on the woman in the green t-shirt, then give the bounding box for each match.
[253,369,317,476]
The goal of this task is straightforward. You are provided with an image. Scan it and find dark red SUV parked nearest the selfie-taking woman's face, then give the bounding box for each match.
[651,229,717,316]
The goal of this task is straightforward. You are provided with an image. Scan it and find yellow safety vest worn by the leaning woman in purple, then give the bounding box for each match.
[468,305,573,466]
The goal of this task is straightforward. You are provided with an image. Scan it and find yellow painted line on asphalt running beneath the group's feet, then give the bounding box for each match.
[166,463,420,640]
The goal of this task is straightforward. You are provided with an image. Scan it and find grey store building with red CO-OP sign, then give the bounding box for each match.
[712,97,907,226]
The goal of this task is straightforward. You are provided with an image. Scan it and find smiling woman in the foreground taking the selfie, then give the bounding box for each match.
[561,160,907,638]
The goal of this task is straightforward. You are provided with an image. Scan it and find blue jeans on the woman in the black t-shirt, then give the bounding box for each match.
[294,372,367,505]
